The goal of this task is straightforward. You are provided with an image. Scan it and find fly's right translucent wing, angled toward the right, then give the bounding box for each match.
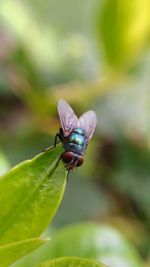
[78,110,97,144]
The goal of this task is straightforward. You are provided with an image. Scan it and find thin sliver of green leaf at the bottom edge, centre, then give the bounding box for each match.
[37,257,106,267]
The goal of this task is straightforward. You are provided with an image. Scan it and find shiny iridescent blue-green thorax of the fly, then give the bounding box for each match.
[64,128,86,155]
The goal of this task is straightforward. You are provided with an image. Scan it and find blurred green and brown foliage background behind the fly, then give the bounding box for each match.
[0,0,150,267]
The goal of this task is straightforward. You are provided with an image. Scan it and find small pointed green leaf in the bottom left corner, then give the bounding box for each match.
[0,238,49,267]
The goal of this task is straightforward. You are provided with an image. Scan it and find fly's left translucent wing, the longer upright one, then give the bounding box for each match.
[58,99,78,136]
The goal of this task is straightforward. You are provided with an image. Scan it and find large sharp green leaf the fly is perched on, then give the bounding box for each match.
[0,146,66,247]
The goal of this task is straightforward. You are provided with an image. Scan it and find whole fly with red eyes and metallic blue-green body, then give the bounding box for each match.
[54,100,97,171]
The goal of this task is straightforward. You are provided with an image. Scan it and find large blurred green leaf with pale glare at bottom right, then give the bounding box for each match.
[47,223,142,267]
